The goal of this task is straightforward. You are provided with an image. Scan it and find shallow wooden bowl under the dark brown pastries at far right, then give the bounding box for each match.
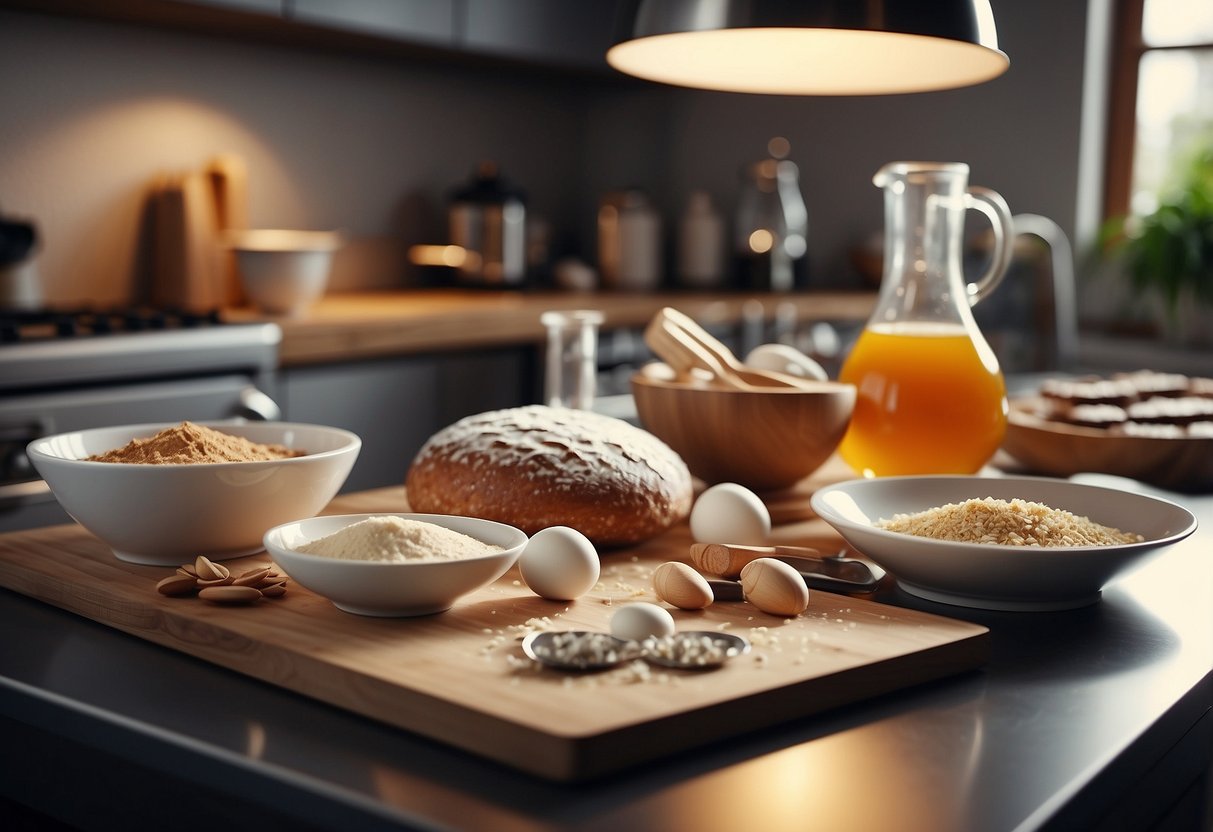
[1002,398,1213,492]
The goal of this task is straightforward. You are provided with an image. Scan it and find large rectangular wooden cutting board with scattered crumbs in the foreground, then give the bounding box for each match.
[0,488,987,780]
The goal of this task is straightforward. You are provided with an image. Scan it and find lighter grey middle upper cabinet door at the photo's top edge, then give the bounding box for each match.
[285,0,456,47]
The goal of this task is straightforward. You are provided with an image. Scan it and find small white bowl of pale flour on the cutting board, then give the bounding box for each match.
[264,513,526,617]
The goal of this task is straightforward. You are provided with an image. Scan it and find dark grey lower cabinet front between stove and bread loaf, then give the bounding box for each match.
[278,347,537,491]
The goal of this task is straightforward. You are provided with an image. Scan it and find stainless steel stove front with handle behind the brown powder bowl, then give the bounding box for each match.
[0,308,281,531]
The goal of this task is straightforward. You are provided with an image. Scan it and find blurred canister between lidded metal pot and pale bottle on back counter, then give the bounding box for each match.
[598,188,661,291]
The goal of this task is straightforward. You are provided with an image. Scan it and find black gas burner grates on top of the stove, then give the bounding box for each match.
[0,307,224,343]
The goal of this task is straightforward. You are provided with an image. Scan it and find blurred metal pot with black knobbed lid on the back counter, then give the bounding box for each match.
[448,161,526,289]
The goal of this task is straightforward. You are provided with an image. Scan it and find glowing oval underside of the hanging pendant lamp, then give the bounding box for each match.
[607,28,1010,96]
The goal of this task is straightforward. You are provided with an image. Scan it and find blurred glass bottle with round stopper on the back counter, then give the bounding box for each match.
[733,136,809,292]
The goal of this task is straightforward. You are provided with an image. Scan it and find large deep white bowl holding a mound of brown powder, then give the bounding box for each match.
[27,422,363,565]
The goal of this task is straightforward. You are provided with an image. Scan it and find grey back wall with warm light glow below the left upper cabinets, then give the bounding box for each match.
[0,12,582,303]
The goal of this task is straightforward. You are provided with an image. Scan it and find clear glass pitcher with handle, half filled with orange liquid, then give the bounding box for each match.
[838,161,1013,477]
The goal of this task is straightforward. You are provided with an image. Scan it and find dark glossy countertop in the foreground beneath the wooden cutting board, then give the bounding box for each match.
[0,473,1213,832]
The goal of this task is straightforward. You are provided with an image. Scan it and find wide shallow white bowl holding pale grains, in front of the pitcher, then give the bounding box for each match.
[810,477,1196,610]
